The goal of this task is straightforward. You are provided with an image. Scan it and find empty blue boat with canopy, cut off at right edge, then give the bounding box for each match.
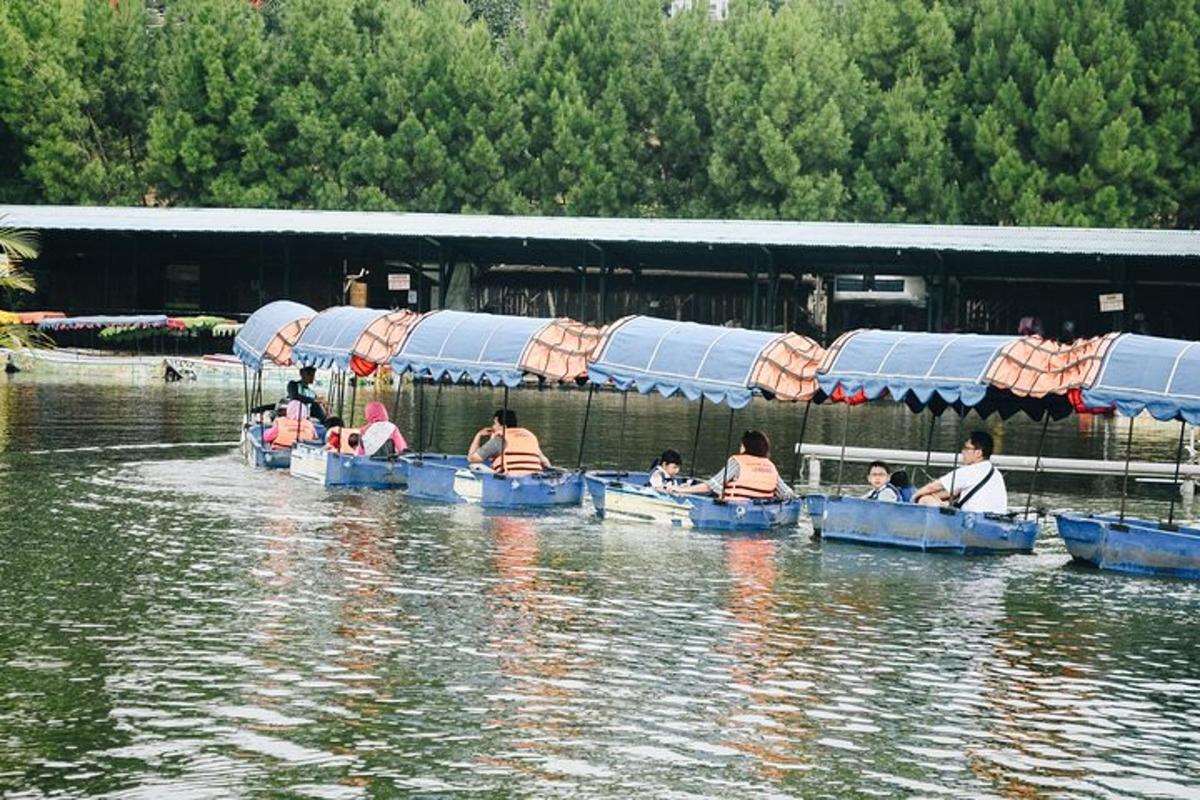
[1055,333,1200,579]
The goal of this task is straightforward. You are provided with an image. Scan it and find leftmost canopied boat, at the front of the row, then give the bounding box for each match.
[233,300,317,469]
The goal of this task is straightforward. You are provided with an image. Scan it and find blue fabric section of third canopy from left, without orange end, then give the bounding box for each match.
[391,311,556,386]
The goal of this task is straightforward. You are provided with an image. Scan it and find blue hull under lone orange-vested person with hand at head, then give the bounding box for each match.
[401,453,583,509]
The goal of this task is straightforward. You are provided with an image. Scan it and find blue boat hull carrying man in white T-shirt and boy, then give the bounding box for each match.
[805,494,1038,553]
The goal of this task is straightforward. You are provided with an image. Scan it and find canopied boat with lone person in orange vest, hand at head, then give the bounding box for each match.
[391,311,599,510]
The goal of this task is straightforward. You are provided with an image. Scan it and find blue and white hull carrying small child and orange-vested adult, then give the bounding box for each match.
[584,471,802,533]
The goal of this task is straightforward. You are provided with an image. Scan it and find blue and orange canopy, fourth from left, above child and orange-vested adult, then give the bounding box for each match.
[588,317,824,408]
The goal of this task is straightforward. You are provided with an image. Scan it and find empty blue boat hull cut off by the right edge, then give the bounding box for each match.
[1055,513,1200,579]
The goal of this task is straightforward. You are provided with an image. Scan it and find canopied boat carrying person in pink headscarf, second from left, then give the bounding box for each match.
[289,306,419,489]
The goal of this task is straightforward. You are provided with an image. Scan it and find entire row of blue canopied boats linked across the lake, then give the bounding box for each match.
[234,301,1200,578]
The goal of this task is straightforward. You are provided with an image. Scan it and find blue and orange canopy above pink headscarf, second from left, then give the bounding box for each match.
[292,306,420,377]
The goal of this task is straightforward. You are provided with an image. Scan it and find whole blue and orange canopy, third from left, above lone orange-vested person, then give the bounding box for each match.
[391,311,600,386]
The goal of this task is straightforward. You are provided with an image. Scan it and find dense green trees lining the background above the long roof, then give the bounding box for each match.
[0,0,1200,227]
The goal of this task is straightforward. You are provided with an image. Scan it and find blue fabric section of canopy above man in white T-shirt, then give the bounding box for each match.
[817,330,1015,408]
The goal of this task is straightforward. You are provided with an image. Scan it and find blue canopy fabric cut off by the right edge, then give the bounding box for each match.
[1084,333,1200,425]
